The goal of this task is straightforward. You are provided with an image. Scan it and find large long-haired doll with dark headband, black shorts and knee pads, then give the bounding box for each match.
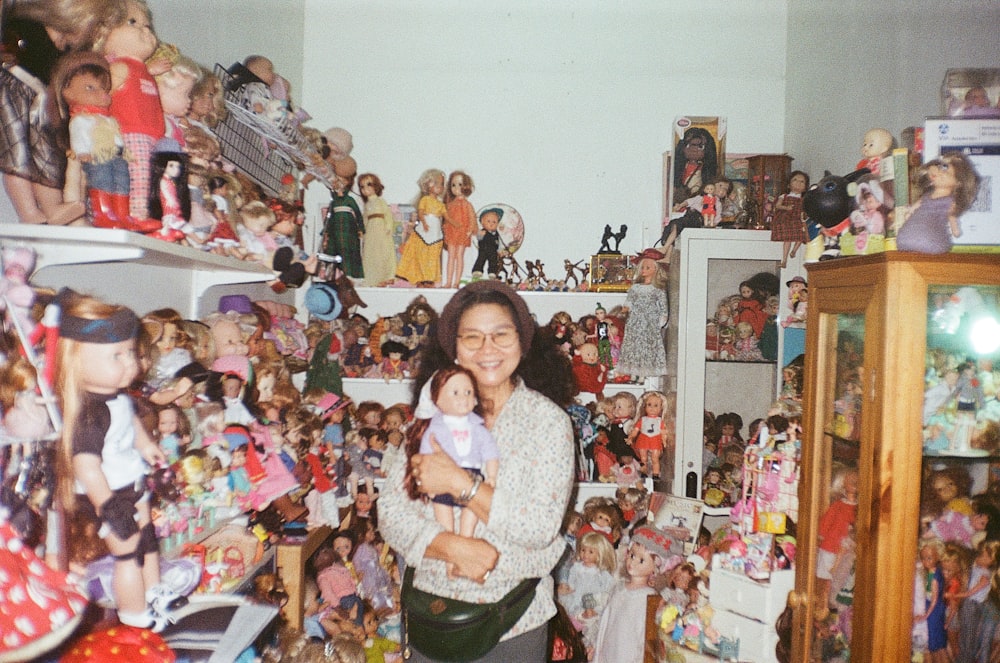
[57,290,184,631]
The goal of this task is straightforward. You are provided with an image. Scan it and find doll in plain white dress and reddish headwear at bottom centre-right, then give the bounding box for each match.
[592,527,670,663]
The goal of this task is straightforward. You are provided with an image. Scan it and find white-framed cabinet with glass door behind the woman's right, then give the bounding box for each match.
[673,228,801,498]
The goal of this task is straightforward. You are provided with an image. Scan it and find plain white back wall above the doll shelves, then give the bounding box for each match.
[302,0,786,275]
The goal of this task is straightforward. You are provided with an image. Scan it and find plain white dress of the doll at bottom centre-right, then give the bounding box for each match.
[592,583,656,663]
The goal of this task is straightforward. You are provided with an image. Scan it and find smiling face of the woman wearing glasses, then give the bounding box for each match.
[455,304,521,392]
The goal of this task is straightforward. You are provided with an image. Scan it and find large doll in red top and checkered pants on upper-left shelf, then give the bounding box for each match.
[99,0,165,221]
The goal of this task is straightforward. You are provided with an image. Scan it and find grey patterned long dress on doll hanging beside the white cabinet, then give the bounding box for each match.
[615,283,667,380]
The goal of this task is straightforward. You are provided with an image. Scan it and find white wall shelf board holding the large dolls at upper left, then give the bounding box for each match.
[0,224,274,318]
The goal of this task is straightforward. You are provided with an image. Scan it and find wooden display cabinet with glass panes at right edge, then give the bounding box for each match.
[788,252,1000,663]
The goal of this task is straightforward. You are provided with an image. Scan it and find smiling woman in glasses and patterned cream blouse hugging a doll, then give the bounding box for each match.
[379,281,574,661]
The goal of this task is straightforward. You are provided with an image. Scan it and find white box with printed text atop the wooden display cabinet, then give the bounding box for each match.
[924,117,1000,253]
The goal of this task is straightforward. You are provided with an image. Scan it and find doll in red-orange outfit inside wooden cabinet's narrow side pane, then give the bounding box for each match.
[816,467,858,610]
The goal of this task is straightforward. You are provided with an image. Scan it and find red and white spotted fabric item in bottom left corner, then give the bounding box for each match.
[0,521,87,663]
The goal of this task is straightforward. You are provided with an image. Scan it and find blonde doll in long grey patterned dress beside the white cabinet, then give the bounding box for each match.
[615,249,668,382]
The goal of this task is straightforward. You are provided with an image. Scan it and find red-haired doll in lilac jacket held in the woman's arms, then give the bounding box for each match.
[407,365,500,537]
